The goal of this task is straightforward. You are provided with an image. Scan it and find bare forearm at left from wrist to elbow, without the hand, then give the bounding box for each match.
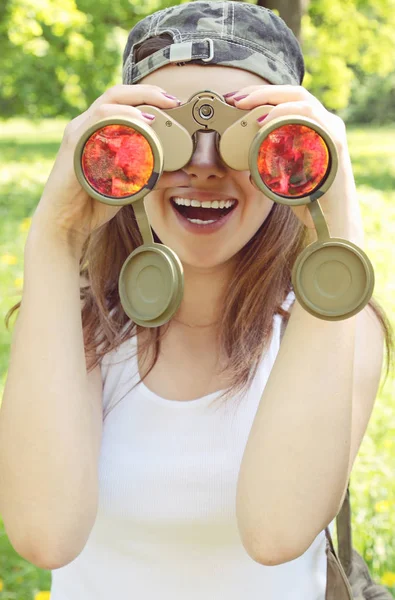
[0,225,102,569]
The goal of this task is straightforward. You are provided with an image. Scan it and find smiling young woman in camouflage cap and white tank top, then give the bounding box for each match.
[0,1,393,600]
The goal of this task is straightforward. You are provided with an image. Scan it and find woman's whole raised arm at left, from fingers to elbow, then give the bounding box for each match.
[0,84,179,569]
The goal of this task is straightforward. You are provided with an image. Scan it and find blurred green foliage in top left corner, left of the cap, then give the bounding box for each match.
[0,0,174,118]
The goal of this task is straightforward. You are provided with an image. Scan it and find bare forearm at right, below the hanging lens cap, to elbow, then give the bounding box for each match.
[237,301,383,565]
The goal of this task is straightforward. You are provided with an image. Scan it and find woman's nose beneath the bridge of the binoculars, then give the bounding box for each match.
[183,131,226,181]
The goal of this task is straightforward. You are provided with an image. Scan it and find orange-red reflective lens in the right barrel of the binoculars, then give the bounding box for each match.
[258,124,330,198]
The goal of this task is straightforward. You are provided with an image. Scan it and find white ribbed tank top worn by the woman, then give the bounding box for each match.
[51,292,335,600]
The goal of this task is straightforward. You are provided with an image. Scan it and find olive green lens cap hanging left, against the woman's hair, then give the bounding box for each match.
[118,243,184,327]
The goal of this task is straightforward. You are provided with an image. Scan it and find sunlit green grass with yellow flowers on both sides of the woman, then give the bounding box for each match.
[0,119,395,600]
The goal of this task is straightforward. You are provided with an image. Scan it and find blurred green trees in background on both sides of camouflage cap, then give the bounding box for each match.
[0,0,395,122]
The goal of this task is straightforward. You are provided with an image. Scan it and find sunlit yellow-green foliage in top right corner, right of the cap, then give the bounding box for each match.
[302,0,395,112]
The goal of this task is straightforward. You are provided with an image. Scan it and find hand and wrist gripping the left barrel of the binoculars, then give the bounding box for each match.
[27,84,183,253]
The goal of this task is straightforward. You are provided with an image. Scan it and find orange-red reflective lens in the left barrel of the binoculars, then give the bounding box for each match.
[81,125,154,198]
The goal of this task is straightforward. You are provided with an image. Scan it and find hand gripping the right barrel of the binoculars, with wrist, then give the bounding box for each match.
[225,85,364,247]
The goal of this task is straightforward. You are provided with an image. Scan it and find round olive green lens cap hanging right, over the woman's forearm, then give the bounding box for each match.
[292,238,374,321]
